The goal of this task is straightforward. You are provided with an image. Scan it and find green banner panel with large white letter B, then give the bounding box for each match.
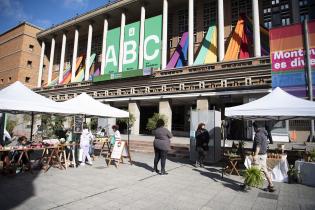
[123,21,140,71]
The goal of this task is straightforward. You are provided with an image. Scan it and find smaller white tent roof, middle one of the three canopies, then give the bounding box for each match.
[60,93,129,118]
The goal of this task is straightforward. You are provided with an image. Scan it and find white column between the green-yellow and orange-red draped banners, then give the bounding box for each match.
[218,0,225,62]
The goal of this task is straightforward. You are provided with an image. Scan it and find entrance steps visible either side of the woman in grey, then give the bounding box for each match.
[129,140,189,159]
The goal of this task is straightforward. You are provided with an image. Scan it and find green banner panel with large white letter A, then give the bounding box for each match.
[105,27,120,73]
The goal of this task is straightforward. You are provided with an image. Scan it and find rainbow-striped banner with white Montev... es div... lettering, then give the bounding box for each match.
[270,21,315,97]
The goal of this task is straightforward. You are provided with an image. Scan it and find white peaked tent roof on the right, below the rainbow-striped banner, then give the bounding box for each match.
[225,87,315,120]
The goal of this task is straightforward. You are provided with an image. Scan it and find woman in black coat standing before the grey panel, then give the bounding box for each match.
[196,123,210,167]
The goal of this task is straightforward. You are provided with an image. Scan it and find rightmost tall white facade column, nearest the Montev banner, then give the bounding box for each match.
[252,0,261,57]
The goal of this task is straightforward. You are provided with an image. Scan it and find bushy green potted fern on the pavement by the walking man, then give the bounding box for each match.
[244,166,264,187]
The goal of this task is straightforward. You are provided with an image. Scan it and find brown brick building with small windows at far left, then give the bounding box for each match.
[0,22,47,88]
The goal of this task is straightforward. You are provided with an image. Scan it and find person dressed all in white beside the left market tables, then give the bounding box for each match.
[80,123,94,165]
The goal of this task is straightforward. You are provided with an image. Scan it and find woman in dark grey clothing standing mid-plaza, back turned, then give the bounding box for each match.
[153,119,173,175]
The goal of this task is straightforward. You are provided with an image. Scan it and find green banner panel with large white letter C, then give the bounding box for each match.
[143,15,162,68]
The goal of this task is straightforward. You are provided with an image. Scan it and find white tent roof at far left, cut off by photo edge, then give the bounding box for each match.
[0,81,75,114]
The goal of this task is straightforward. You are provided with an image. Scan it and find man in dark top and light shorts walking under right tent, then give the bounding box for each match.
[253,123,275,192]
